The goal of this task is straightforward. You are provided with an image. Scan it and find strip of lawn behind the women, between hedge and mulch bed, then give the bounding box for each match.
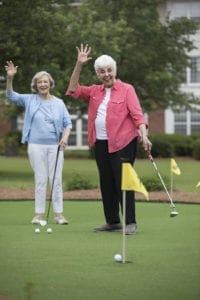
[0,157,200,192]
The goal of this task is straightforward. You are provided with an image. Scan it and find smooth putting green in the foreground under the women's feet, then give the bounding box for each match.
[0,201,200,300]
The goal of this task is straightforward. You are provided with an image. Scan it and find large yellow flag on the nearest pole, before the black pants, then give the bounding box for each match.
[121,163,149,200]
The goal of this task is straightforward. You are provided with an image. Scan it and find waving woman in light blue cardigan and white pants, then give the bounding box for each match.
[5,61,72,224]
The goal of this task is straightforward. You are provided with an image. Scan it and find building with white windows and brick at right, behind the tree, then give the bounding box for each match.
[155,0,200,135]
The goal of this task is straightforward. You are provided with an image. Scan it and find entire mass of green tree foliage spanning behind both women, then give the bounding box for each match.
[0,0,197,119]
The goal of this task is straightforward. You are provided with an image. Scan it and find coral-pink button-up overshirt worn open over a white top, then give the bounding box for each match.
[65,79,147,153]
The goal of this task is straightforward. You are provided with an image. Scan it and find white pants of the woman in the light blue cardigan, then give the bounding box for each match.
[28,144,64,214]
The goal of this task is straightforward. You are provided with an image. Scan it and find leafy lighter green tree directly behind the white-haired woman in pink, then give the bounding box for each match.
[65,0,199,111]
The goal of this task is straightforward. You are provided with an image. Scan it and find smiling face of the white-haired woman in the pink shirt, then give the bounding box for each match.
[96,66,116,88]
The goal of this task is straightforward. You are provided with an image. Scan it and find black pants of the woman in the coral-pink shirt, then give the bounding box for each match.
[95,138,137,224]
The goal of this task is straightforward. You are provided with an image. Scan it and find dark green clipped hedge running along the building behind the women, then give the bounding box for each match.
[0,130,200,160]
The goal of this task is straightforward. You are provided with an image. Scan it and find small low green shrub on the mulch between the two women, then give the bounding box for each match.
[66,173,95,191]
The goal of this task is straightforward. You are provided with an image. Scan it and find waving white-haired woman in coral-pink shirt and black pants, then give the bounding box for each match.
[66,44,152,234]
